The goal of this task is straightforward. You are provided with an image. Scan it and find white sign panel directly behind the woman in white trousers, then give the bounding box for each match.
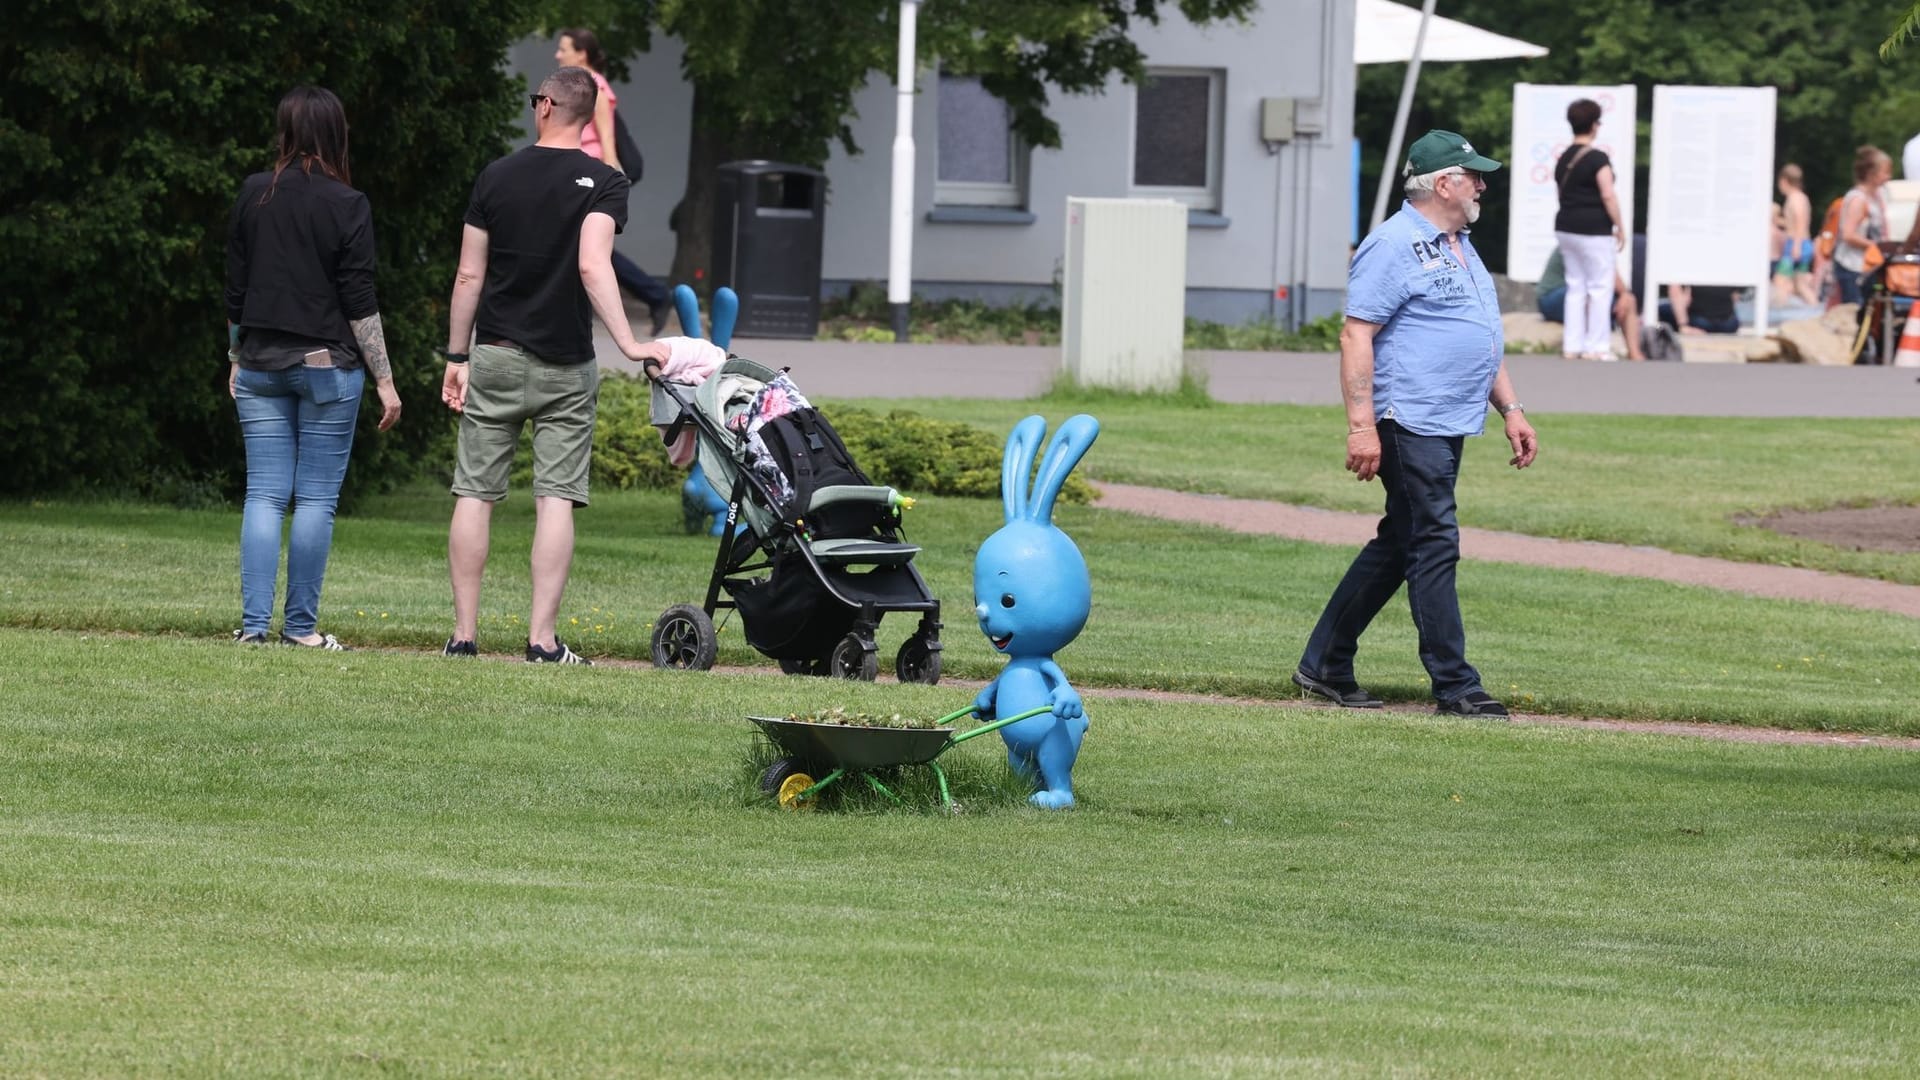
[1507,83,1638,281]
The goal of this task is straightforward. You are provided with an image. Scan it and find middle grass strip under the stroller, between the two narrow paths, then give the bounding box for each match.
[0,490,1920,734]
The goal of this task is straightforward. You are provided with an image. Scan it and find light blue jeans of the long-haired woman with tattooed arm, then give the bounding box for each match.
[234,365,367,638]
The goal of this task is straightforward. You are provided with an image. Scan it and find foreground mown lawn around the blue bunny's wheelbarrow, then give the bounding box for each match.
[0,630,1920,1076]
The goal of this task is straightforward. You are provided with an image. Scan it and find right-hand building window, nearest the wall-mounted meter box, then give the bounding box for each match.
[1131,69,1225,209]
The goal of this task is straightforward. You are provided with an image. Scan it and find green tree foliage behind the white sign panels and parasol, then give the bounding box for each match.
[1356,0,1920,269]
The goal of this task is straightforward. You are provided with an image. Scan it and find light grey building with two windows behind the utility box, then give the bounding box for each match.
[511,0,1354,323]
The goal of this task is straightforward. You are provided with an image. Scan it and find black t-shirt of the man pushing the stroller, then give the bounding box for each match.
[467,146,628,363]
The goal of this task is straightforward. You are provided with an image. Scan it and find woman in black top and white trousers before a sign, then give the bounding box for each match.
[1553,98,1626,359]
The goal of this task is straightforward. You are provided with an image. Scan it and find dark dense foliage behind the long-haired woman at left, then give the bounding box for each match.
[0,0,526,492]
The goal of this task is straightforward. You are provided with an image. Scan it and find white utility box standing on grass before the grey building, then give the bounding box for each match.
[1060,198,1187,390]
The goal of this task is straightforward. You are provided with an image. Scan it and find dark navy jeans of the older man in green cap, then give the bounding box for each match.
[1300,421,1480,703]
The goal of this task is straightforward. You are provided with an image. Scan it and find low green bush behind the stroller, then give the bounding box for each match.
[560,373,1094,503]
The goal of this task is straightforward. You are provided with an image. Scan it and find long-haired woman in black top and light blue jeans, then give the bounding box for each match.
[227,86,399,650]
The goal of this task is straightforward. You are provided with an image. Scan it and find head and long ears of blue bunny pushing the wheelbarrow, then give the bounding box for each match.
[973,413,1100,657]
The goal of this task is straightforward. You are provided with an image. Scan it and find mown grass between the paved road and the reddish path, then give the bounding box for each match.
[856,393,1920,584]
